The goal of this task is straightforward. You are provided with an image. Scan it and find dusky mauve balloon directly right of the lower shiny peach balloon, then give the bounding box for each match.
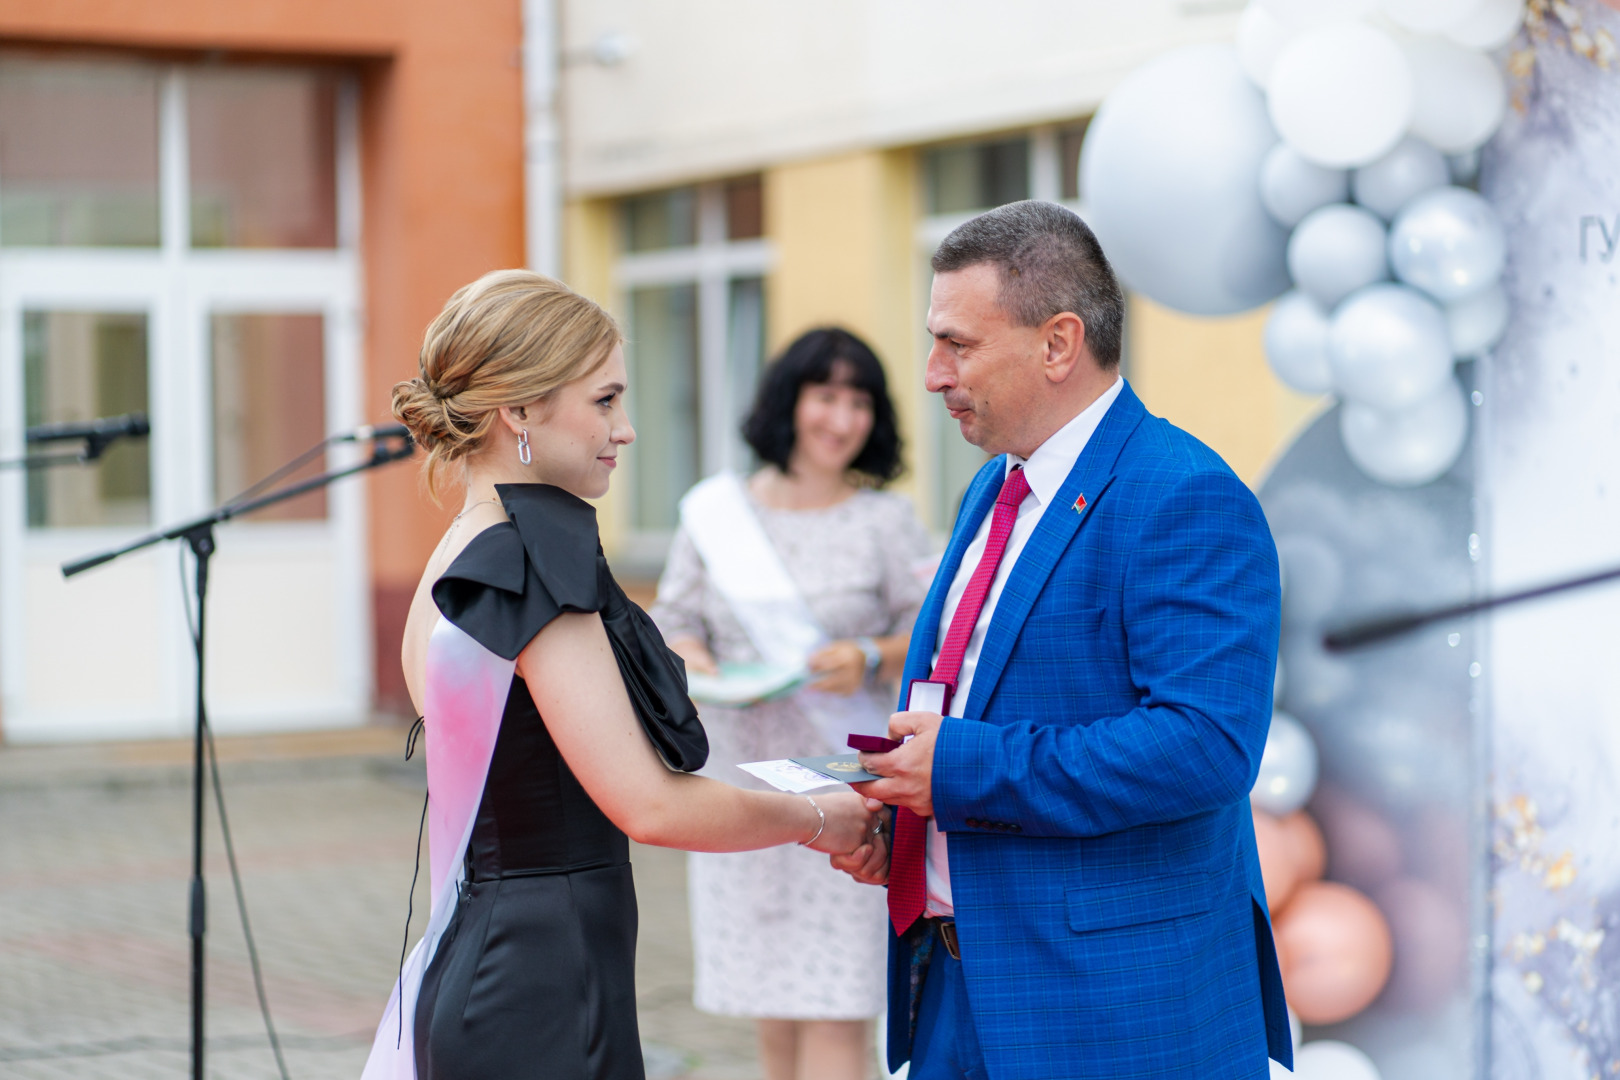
[1377,878,1468,1012]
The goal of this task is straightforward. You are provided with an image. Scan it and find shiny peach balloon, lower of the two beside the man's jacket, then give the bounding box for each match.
[1272,881,1393,1025]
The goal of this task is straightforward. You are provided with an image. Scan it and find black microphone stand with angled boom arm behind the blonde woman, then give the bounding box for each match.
[62,436,416,1080]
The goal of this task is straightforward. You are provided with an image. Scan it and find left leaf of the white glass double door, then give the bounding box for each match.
[0,279,183,740]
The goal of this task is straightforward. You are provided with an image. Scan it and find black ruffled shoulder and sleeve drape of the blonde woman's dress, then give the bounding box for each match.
[433,484,708,772]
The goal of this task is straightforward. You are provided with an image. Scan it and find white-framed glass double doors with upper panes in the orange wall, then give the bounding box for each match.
[0,49,371,738]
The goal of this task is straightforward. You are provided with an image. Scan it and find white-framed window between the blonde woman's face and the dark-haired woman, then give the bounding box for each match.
[614,176,771,573]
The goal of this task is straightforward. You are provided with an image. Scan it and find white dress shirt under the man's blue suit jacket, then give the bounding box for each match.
[923,379,1124,916]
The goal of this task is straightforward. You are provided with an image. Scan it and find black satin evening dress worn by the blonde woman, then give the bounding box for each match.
[415,484,708,1080]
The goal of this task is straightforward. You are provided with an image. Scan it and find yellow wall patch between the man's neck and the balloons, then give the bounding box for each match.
[1126,296,1322,487]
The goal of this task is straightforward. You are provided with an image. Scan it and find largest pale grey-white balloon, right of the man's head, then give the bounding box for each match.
[1081,45,1288,316]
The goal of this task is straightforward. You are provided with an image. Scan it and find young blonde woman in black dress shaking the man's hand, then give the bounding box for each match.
[366,270,875,1080]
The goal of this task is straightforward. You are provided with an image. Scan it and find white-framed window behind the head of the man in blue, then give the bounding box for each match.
[917,118,1090,531]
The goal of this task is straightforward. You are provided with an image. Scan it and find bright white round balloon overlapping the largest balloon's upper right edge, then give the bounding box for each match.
[1267,23,1413,168]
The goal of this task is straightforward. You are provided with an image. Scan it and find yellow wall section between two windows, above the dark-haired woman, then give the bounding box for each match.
[765,151,925,508]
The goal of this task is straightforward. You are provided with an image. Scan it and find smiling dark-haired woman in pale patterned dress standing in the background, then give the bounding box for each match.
[651,329,928,1080]
